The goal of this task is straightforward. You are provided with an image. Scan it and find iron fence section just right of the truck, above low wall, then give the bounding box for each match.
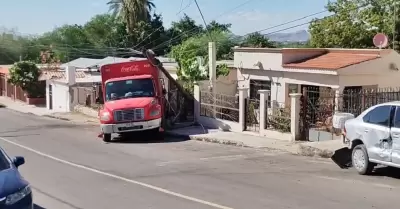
[200,91,239,122]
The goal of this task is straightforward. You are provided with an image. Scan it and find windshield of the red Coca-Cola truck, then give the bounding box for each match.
[105,78,155,101]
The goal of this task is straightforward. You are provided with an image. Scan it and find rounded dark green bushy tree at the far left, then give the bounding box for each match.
[8,61,40,95]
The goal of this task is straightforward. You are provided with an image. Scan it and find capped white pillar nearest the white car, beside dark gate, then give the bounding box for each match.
[290,93,302,141]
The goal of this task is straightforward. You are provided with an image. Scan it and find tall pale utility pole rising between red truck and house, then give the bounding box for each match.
[208,42,217,117]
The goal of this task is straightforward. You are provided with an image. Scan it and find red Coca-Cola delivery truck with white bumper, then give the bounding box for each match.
[99,60,166,142]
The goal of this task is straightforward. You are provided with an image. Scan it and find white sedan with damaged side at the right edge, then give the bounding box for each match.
[343,102,400,175]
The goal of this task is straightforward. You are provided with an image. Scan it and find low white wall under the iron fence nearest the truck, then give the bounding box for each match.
[197,116,242,132]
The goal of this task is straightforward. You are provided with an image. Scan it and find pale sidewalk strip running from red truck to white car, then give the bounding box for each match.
[167,126,344,158]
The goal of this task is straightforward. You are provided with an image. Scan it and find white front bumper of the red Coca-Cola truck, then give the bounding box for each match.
[100,118,161,134]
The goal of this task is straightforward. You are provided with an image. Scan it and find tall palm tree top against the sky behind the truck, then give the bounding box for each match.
[107,0,155,31]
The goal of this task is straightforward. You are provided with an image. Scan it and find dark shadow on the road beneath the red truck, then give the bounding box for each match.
[107,132,190,144]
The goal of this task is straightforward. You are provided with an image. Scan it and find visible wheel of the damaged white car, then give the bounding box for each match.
[351,144,374,175]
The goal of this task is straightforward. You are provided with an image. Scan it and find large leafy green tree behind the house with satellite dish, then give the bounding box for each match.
[309,0,400,48]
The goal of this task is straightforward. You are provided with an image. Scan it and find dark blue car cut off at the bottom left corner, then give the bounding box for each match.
[0,147,33,209]
